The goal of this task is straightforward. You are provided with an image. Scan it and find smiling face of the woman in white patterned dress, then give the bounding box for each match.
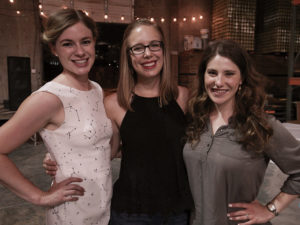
[51,22,95,77]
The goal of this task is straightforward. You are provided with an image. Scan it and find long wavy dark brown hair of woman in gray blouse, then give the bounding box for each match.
[187,40,273,152]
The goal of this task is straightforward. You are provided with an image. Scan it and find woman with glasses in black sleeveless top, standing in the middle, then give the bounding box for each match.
[105,19,193,225]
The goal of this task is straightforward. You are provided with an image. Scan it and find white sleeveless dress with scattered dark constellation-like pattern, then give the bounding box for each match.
[37,81,112,225]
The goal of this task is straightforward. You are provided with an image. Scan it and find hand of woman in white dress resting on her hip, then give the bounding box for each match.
[39,177,85,206]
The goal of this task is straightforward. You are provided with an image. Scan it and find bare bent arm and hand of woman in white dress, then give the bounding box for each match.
[0,93,83,205]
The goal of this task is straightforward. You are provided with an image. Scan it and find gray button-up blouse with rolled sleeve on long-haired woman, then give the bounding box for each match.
[183,118,300,225]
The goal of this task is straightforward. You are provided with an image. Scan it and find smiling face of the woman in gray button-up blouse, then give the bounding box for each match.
[204,55,242,109]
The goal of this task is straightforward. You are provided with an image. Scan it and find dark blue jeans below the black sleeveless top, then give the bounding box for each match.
[109,211,188,225]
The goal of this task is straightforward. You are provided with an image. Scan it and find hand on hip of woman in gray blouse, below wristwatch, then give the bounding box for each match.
[227,200,275,225]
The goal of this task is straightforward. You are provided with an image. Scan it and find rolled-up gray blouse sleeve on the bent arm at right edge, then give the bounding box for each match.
[266,118,300,195]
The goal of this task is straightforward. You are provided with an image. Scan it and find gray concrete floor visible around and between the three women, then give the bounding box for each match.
[0,143,300,225]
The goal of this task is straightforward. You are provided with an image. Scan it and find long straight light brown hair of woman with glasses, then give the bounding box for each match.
[117,19,178,110]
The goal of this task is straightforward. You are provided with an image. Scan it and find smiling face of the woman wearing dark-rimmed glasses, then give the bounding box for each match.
[128,25,163,79]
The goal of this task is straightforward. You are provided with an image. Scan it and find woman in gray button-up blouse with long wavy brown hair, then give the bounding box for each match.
[184,40,300,225]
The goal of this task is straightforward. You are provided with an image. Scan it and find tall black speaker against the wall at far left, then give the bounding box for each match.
[7,56,31,111]
